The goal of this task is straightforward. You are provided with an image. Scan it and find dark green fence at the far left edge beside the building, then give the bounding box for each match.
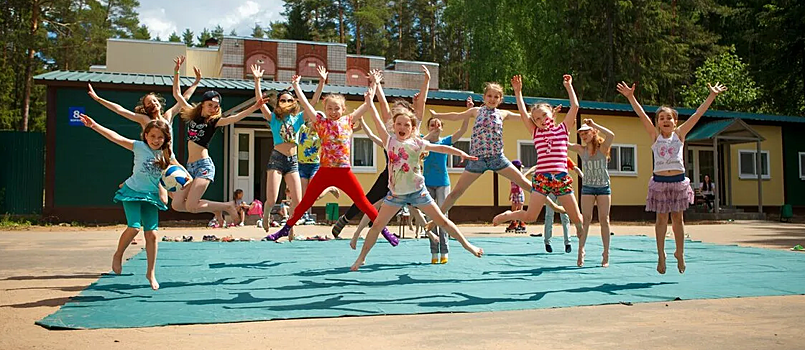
[0,131,45,214]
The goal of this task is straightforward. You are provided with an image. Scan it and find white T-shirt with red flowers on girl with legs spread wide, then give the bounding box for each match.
[385,136,428,196]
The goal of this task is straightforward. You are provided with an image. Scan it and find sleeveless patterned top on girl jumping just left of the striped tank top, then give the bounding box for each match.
[469,107,503,158]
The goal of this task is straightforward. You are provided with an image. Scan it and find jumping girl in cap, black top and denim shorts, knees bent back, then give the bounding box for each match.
[173,63,265,227]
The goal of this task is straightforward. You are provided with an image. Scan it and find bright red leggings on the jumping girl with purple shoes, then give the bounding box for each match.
[286,168,377,226]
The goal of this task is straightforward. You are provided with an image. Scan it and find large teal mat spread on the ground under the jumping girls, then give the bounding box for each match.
[37,236,805,329]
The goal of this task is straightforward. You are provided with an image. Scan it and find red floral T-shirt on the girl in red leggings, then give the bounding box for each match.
[313,112,352,168]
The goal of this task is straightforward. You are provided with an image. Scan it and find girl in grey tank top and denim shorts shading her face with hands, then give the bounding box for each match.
[570,119,615,267]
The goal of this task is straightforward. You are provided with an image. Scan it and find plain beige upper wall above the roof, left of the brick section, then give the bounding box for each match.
[106,39,188,76]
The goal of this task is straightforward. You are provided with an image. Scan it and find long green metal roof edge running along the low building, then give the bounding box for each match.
[34,71,805,123]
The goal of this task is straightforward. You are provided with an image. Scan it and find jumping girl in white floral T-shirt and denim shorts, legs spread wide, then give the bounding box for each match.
[350,87,484,271]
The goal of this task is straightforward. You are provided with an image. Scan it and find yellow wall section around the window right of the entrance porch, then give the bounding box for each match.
[730,124,784,206]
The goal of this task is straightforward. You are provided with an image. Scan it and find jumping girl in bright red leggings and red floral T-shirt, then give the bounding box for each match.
[265,75,399,246]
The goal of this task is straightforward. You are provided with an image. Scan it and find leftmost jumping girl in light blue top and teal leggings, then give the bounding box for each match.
[80,114,172,290]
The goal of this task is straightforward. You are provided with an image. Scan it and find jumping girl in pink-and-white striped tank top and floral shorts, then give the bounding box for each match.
[492,75,584,266]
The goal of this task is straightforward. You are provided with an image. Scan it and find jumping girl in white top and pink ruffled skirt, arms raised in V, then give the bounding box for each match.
[618,82,727,274]
